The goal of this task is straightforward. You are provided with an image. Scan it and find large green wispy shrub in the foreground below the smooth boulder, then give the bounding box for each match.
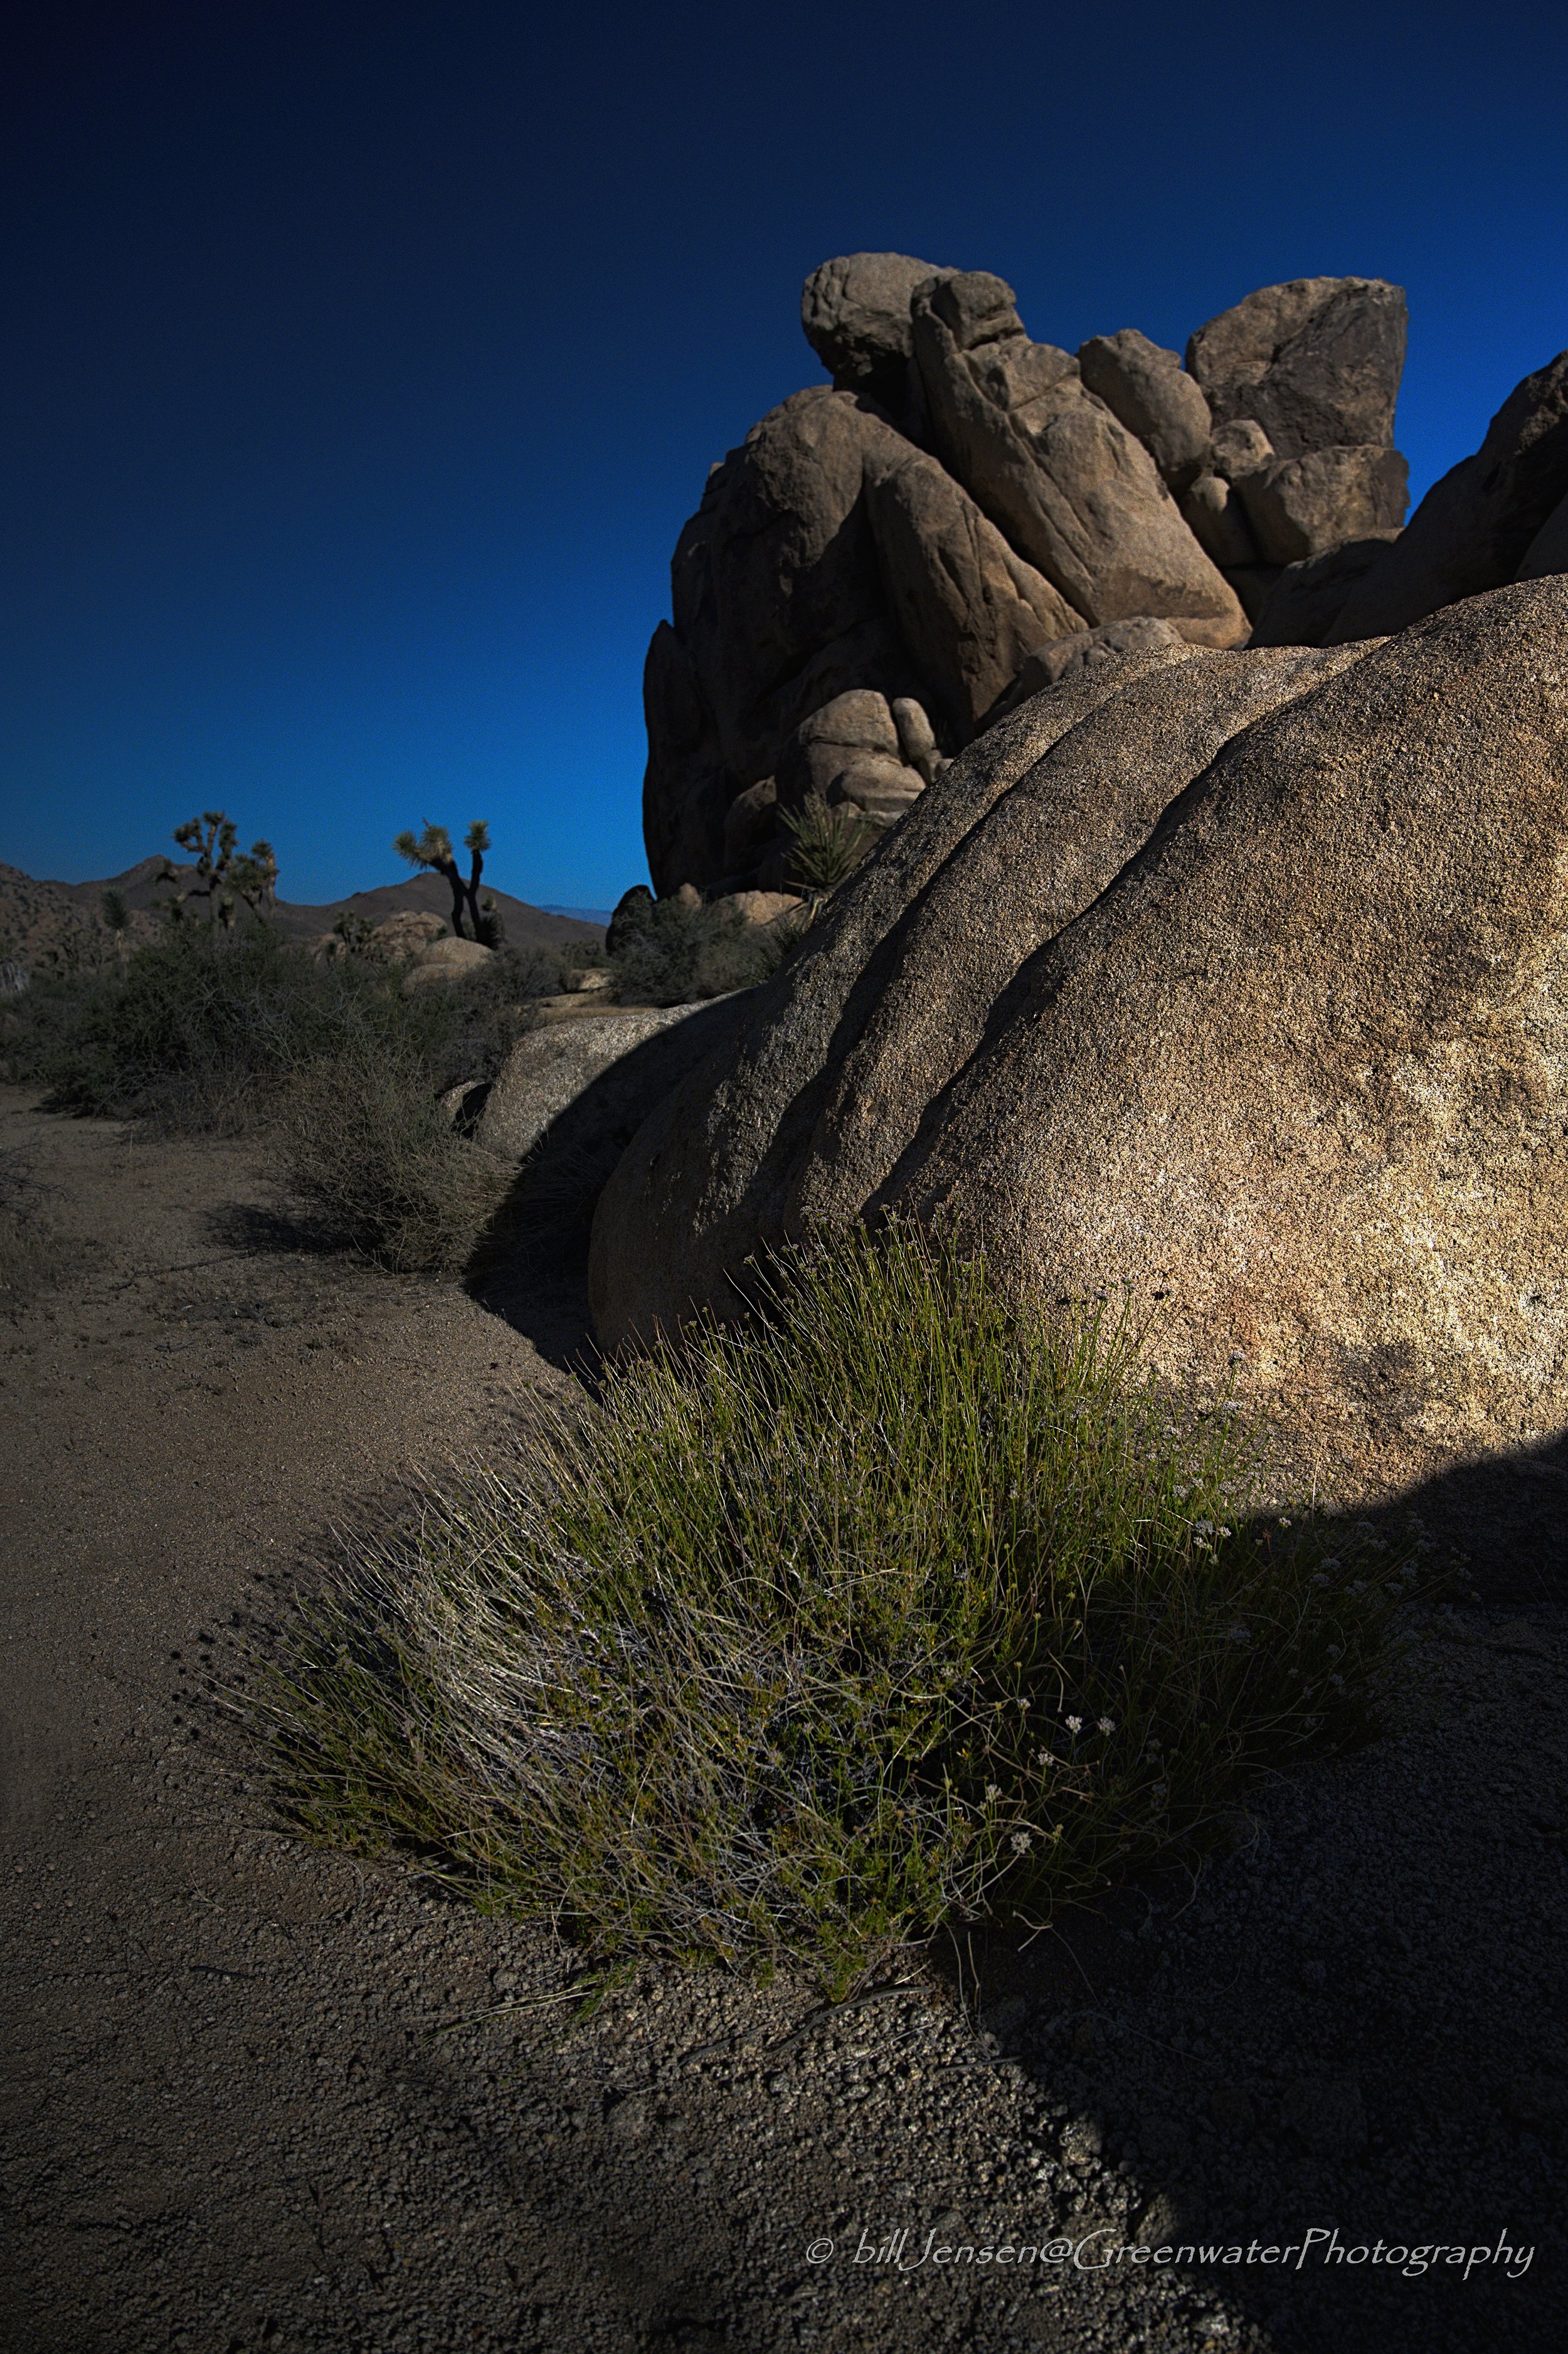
[253,1226,1415,1987]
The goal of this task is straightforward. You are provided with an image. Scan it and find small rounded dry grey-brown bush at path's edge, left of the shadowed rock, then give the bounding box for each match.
[278,1036,511,1273]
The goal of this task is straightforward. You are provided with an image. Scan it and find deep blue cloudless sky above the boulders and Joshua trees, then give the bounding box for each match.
[0,0,1568,904]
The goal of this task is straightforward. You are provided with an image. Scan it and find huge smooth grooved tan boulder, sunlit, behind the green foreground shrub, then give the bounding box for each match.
[593,576,1568,1483]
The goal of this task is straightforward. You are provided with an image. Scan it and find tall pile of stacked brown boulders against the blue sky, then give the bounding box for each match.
[643,254,1406,894]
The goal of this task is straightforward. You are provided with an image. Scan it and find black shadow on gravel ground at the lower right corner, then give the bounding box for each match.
[930,1436,1568,2354]
